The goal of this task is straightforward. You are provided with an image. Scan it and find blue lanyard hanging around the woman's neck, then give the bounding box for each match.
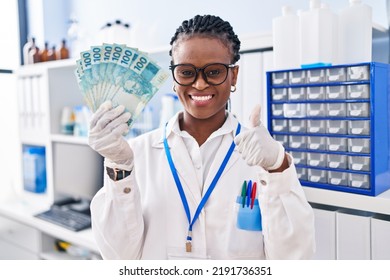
[164,123,241,252]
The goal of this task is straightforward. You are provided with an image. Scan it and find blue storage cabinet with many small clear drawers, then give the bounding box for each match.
[267,62,390,196]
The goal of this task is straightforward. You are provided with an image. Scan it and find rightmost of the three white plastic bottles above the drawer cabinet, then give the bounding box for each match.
[339,0,372,64]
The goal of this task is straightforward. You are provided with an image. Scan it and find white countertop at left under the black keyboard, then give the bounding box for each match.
[0,195,99,253]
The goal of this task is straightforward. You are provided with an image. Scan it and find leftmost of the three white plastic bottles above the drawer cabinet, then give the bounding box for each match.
[272,6,300,70]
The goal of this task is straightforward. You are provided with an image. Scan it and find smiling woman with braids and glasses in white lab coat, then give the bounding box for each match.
[89,15,315,259]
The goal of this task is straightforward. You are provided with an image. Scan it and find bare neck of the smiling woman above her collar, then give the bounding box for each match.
[179,112,226,146]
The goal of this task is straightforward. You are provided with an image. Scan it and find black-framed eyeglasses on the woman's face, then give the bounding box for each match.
[169,63,235,86]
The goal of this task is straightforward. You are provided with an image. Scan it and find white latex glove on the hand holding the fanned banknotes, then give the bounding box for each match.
[88,101,134,171]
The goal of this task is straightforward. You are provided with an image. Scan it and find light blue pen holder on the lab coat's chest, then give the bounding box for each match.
[236,196,262,231]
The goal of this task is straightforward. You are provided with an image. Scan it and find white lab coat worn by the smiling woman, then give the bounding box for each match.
[91,112,315,259]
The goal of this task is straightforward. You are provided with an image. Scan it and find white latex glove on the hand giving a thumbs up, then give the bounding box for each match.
[234,105,285,170]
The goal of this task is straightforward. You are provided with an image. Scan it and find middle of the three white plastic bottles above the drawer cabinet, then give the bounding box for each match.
[299,0,337,68]
